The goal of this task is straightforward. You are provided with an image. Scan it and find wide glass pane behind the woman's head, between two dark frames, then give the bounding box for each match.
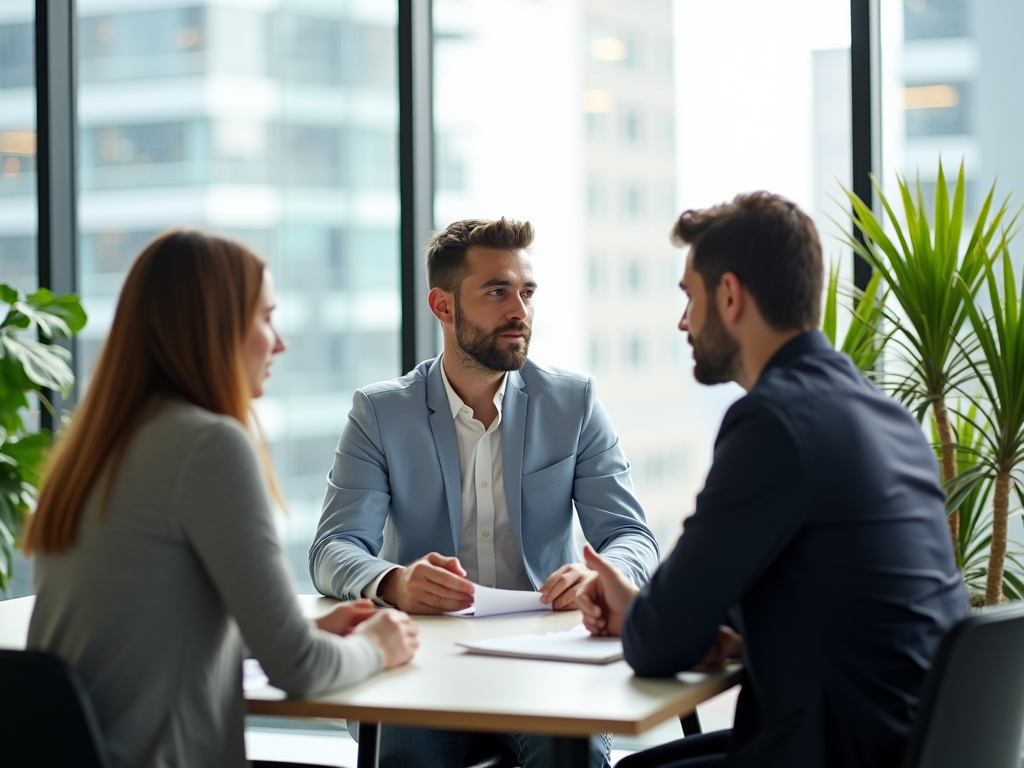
[78,0,399,592]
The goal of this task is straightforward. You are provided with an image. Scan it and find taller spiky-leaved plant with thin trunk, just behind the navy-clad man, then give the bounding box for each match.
[846,162,1009,548]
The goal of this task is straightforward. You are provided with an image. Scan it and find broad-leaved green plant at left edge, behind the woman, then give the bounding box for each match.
[0,283,87,591]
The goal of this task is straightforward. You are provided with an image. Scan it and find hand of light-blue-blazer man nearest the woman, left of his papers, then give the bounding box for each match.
[377,552,473,613]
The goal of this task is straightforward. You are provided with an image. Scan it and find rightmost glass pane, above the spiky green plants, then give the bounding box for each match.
[882,0,1024,227]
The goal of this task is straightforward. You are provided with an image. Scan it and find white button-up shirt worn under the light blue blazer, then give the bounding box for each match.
[362,358,534,602]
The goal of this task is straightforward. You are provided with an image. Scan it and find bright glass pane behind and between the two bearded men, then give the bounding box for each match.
[434,0,850,551]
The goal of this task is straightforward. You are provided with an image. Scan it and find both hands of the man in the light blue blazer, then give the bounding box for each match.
[378,552,597,613]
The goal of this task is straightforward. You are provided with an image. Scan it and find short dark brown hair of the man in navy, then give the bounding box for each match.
[672,191,824,331]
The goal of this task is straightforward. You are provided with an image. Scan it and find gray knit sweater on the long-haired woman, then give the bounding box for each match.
[29,402,381,768]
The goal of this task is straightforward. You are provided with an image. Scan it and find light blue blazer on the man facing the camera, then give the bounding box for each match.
[309,357,658,599]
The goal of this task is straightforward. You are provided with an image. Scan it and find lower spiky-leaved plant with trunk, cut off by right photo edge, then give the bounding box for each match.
[951,232,1024,605]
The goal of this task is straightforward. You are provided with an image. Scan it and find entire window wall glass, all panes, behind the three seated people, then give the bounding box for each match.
[19,0,983,588]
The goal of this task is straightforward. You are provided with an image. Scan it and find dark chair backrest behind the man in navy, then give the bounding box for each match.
[903,605,1024,768]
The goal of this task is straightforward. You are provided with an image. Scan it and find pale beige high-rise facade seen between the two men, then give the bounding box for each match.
[582,0,688,548]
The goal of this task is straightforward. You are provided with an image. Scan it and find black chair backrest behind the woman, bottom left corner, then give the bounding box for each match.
[0,650,110,768]
